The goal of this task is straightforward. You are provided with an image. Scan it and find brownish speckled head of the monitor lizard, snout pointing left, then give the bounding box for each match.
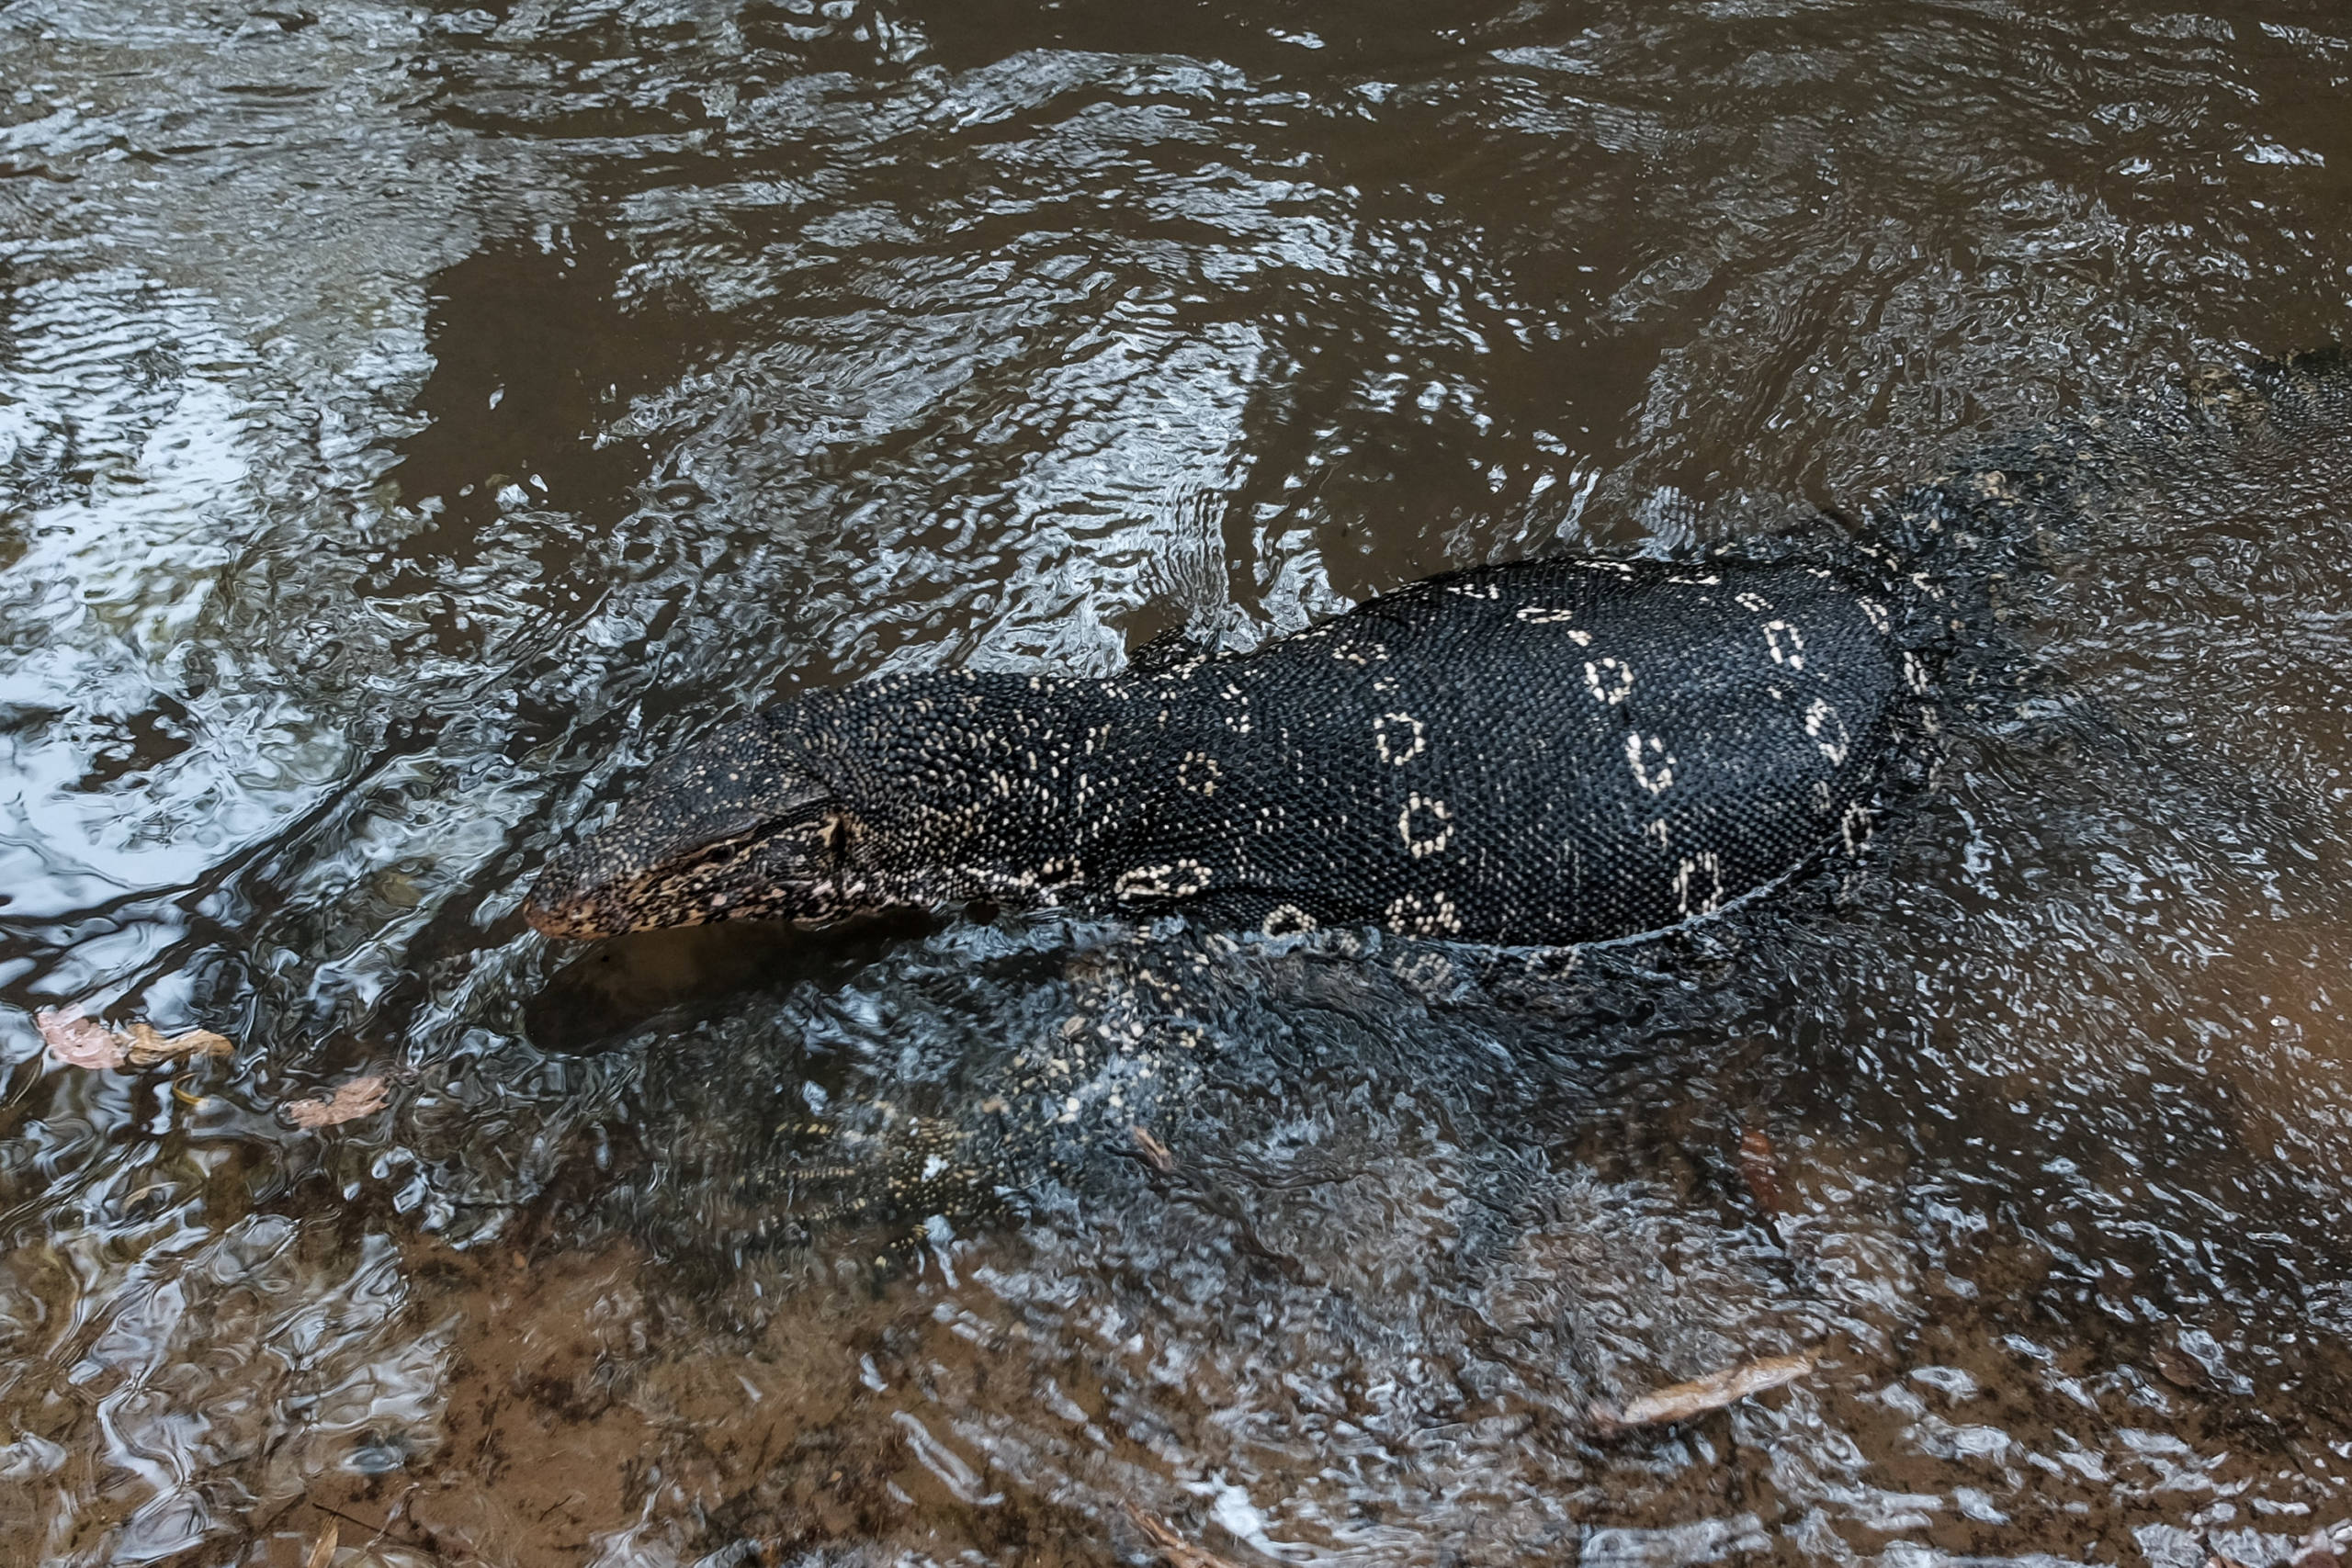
[522,717,870,938]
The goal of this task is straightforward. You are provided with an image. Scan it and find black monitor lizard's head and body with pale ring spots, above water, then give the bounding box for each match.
[526,558,1928,945]
